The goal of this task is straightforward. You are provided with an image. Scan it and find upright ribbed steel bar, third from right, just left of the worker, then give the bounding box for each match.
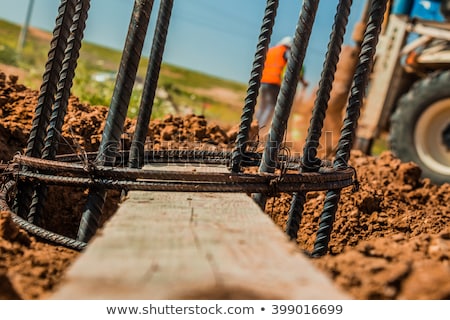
[253,0,319,210]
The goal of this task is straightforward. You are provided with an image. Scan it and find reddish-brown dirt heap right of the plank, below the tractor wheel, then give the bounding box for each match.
[266,152,450,299]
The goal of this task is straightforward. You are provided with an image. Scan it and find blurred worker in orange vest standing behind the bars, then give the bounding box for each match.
[256,37,308,129]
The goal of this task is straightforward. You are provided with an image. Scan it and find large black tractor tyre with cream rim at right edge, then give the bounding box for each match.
[390,71,450,184]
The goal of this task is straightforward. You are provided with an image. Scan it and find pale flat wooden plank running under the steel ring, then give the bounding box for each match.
[52,167,347,300]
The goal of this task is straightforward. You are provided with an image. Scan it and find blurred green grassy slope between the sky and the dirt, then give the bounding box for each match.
[0,20,246,124]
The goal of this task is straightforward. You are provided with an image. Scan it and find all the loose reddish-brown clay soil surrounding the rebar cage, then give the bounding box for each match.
[0,72,450,299]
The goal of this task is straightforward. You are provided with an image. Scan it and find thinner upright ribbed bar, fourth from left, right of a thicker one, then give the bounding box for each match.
[129,0,173,168]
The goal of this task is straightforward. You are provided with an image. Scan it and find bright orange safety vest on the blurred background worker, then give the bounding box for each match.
[261,45,288,86]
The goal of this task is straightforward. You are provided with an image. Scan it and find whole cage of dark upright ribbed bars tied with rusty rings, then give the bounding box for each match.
[0,0,387,257]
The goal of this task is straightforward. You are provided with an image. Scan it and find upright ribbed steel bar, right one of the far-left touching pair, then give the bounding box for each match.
[28,0,90,225]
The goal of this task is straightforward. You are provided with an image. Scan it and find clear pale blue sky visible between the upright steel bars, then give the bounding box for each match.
[0,0,365,83]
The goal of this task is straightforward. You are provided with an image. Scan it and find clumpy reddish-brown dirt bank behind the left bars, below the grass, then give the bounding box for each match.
[0,71,231,162]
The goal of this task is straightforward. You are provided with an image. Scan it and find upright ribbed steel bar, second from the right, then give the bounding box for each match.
[286,0,353,239]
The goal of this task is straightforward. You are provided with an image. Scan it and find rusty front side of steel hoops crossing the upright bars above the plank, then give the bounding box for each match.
[13,156,354,194]
